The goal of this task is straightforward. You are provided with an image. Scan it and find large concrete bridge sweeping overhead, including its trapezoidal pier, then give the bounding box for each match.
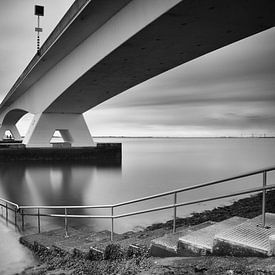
[0,0,275,147]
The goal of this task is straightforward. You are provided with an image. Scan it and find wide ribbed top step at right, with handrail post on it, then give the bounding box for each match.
[213,213,275,256]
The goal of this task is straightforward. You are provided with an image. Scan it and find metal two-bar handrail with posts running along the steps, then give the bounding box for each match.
[0,167,275,240]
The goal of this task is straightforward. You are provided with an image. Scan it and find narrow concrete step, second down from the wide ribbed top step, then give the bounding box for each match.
[150,221,215,257]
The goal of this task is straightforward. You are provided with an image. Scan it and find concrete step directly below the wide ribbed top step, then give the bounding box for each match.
[177,217,247,256]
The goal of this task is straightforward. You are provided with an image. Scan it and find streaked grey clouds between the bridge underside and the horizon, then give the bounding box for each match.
[86,28,275,135]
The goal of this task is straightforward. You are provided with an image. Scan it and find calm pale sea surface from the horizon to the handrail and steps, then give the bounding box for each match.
[0,138,275,274]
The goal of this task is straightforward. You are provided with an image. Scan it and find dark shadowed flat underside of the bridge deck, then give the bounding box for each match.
[46,0,275,113]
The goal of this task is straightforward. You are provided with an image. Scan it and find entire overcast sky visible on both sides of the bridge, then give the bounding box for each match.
[0,0,275,137]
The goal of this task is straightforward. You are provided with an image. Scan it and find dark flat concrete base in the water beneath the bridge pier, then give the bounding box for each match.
[0,143,122,165]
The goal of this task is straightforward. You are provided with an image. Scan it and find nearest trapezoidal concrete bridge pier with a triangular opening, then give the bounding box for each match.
[23,113,96,147]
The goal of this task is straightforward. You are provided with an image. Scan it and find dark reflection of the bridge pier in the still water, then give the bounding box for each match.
[0,162,121,231]
